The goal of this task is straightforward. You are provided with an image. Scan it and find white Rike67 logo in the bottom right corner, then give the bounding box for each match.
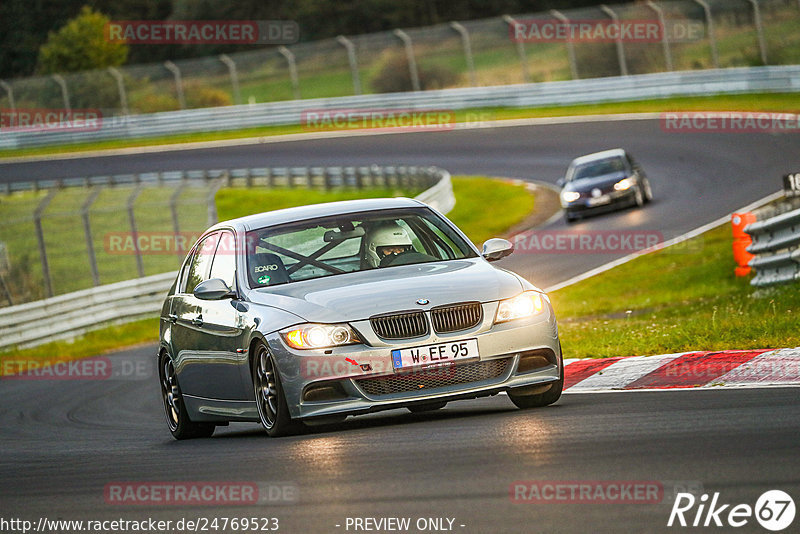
[667,490,795,532]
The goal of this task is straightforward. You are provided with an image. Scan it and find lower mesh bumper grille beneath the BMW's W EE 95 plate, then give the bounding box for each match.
[355,358,511,397]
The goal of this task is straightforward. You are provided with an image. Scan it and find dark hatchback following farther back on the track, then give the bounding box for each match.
[558,148,653,222]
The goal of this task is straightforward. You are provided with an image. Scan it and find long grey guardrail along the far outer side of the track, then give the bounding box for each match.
[0,65,800,149]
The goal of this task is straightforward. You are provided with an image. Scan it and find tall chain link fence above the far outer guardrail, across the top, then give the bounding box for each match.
[0,0,800,117]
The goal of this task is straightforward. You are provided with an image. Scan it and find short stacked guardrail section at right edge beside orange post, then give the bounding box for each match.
[744,199,800,287]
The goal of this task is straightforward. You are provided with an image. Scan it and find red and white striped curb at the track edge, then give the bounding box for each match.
[564,347,800,393]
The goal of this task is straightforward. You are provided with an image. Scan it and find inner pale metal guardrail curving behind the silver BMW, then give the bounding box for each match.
[0,167,455,348]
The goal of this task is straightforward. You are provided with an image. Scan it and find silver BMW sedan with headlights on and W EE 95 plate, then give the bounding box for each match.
[157,198,564,439]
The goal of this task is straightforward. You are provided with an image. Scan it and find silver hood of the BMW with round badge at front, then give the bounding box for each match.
[248,258,523,323]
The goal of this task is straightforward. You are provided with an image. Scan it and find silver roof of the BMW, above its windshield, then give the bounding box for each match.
[206,197,425,233]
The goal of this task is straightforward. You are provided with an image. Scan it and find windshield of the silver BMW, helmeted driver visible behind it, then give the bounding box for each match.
[247,208,477,288]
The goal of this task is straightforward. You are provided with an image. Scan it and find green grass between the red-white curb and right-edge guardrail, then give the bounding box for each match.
[551,225,800,358]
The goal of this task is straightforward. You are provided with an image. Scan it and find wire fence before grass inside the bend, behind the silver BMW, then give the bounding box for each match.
[0,165,440,307]
